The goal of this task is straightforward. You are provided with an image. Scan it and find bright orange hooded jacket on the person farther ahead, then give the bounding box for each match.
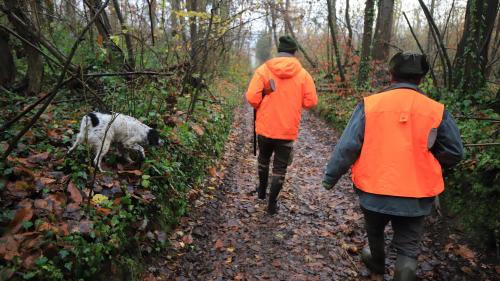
[246,56,318,140]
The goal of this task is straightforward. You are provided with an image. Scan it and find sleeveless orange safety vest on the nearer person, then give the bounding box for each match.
[352,88,444,198]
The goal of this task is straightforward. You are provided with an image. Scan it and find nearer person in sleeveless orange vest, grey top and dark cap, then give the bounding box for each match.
[323,53,463,281]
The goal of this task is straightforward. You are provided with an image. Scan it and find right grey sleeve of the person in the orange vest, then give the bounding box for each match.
[431,110,464,167]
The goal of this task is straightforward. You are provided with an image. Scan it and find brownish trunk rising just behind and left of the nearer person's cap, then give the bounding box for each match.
[372,0,394,61]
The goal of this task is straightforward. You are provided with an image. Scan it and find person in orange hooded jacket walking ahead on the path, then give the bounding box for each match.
[246,36,318,215]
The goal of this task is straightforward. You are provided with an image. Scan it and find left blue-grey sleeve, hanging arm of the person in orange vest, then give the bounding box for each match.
[323,103,365,188]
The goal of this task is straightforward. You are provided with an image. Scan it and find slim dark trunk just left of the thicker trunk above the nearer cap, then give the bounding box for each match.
[358,0,375,84]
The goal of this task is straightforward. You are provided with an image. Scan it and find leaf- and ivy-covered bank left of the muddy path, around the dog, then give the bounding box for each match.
[0,69,242,280]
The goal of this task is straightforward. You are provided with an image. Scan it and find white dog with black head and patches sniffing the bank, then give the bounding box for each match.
[68,112,163,172]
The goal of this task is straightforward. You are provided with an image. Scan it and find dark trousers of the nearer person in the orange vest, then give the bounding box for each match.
[362,208,424,258]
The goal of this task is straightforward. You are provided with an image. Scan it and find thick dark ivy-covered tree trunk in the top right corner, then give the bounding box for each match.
[454,0,499,93]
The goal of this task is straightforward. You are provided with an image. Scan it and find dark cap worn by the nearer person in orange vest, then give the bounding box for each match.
[389,52,429,78]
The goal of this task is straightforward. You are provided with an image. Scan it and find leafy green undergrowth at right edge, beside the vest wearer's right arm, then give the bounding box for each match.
[429,86,500,249]
